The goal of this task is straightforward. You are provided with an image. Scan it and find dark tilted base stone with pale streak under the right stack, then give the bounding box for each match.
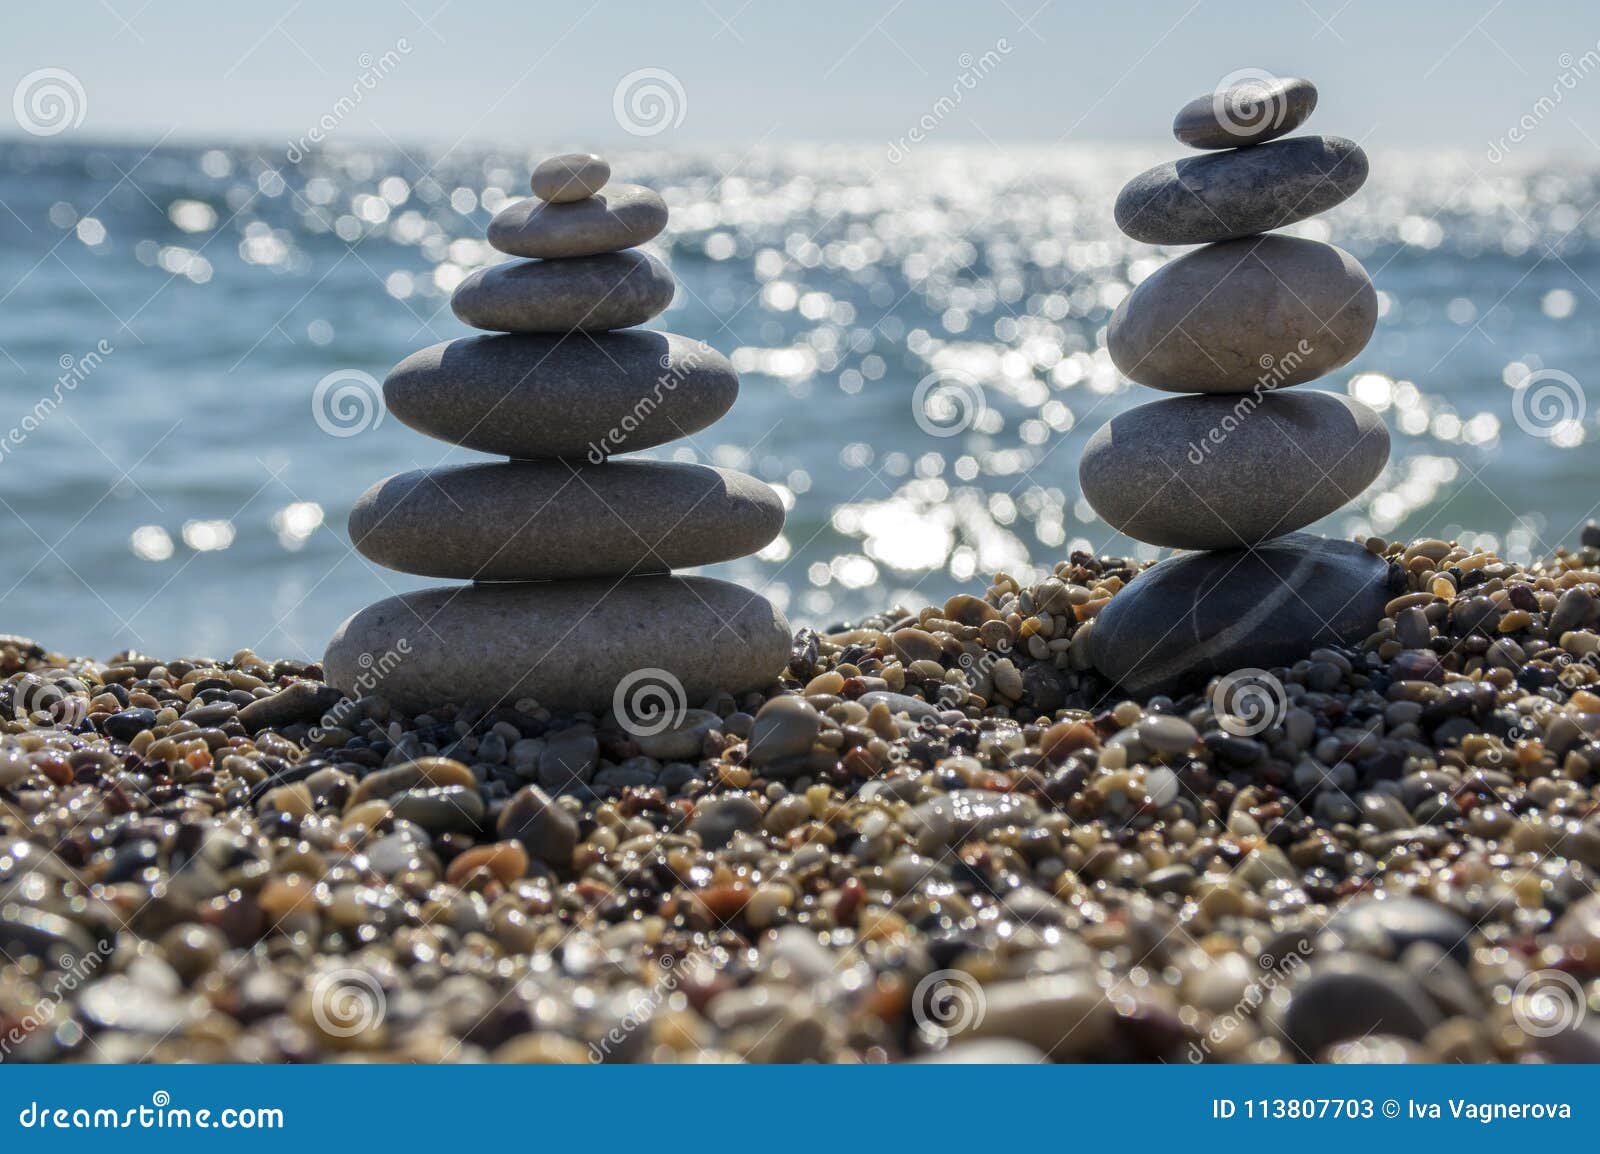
[1090,533,1394,698]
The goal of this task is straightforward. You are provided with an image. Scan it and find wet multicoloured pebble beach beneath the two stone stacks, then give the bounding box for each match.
[0,525,1600,1063]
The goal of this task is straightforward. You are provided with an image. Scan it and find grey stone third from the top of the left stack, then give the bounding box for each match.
[450,248,675,333]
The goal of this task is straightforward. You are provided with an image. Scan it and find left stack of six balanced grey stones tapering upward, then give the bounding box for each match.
[325,154,790,712]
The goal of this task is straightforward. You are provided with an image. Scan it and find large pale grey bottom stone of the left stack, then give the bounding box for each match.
[323,576,790,714]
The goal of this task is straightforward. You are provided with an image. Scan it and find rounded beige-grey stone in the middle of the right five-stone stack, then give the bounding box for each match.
[1106,235,1378,392]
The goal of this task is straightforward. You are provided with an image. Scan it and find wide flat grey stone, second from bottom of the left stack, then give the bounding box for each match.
[350,458,784,581]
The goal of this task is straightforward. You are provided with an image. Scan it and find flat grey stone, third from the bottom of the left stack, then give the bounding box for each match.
[384,331,739,463]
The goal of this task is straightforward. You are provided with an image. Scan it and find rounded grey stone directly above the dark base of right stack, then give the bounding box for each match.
[1078,389,1389,549]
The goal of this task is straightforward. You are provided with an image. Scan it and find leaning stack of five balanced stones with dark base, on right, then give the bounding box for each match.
[1078,74,1389,696]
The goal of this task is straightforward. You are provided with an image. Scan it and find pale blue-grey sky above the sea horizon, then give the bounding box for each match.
[9,0,1600,150]
